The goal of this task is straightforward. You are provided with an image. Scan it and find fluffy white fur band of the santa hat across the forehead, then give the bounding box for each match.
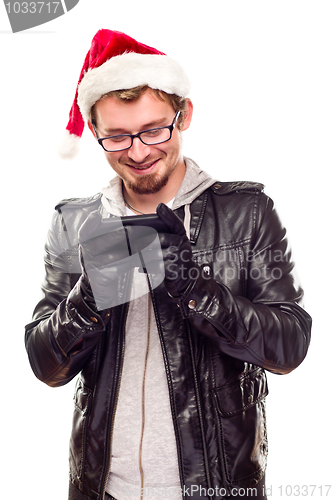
[77,52,190,121]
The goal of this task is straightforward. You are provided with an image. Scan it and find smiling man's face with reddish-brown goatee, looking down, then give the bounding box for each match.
[91,90,191,194]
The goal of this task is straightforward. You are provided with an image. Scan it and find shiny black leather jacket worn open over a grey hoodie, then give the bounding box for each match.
[26,182,311,500]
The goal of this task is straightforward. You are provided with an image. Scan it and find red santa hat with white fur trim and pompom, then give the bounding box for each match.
[59,30,190,159]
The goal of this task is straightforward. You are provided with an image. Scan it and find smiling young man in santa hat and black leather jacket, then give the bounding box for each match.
[26,30,311,500]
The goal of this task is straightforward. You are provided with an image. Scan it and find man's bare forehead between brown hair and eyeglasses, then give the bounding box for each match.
[95,91,174,133]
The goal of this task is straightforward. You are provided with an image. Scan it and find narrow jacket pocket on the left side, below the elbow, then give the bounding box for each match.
[69,378,92,486]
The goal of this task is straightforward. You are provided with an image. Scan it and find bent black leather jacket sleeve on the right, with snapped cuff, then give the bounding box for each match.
[179,194,311,374]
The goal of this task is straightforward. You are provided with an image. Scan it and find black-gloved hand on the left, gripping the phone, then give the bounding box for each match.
[79,211,164,310]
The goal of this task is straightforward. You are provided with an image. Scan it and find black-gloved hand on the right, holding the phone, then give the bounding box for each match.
[156,203,197,298]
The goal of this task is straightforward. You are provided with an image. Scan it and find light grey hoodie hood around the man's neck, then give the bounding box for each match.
[102,158,216,217]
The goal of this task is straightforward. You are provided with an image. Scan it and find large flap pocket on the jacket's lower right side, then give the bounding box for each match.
[213,368,268,486]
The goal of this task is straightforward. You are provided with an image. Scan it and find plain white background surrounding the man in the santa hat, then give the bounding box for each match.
[0,0,333,500]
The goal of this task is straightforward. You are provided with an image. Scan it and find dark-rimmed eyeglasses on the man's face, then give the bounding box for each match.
[92,111,180,153]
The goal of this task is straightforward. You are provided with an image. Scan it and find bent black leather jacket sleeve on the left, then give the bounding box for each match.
[25,212,109,387]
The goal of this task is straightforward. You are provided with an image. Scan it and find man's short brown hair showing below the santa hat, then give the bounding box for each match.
[89,85,187,130]
